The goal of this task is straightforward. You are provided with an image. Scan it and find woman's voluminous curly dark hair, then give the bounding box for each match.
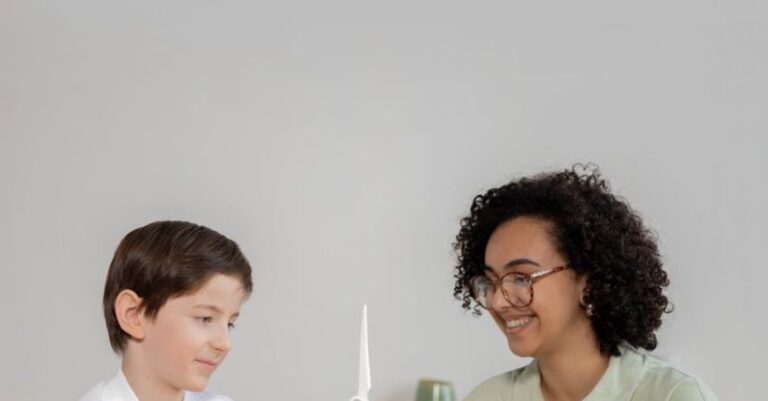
[453,164,671,355]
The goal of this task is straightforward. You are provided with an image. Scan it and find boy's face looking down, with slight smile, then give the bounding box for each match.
[141,274,247,391]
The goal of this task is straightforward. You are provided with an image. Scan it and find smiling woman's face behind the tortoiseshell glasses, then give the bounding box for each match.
[485,217,594,357]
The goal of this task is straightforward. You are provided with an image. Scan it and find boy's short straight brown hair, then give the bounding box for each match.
[103,221,253,353]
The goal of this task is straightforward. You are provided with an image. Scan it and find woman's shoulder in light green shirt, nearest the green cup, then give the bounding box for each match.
[464,361,539,401]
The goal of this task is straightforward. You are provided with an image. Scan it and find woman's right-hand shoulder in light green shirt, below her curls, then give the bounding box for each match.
[622,349,717,401]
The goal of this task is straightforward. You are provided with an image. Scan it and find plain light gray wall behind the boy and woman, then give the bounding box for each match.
[0,0,768,401]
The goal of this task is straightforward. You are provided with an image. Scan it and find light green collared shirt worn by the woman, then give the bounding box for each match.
[464,348,717,401]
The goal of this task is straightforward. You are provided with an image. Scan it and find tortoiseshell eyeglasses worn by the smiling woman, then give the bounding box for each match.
[469,265,568,309]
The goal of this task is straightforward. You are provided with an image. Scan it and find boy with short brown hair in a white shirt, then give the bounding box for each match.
[81,221,253,401]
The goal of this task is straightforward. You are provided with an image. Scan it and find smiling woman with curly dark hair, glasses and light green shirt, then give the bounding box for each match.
[454,165,716,401]
